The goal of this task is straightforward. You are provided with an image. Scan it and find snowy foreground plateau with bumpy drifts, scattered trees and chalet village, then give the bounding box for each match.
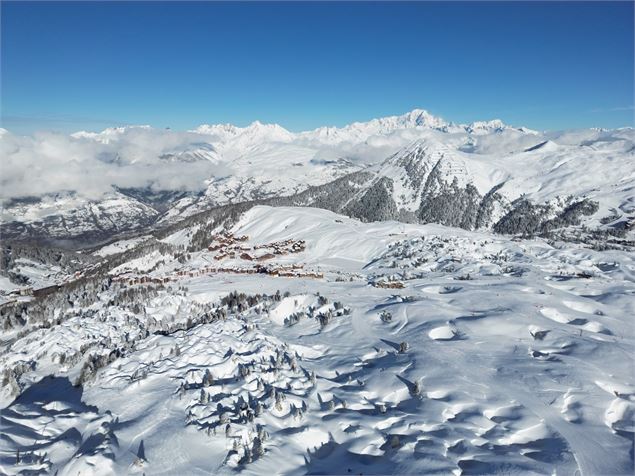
[0,206,635,475]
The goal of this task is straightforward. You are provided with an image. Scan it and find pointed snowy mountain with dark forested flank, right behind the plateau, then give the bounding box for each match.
[268,129,635,239]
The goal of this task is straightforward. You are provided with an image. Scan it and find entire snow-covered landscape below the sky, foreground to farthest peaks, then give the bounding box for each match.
[0,110,635,476]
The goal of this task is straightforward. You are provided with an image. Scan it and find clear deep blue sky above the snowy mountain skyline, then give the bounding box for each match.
[1,1,634,133]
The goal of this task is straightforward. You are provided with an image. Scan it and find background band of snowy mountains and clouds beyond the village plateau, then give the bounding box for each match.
[0,109,635,245]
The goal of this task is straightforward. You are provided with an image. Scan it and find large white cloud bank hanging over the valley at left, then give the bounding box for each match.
[0,127,228,200]
